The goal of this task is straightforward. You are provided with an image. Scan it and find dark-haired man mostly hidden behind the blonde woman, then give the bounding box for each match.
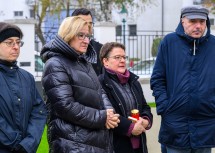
[72,8,102,75]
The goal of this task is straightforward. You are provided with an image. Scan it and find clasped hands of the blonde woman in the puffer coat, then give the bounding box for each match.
[105,109,120,129]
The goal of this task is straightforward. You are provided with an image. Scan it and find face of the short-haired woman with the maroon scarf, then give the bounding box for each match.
[103,47,126,74]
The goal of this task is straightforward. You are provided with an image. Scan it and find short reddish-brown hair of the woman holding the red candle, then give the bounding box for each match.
[99,42,125,65]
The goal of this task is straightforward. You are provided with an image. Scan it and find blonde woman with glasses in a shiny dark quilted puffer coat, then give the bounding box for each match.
[41,17,119,153]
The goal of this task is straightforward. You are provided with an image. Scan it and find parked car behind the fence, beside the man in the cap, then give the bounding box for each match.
[129,57,156,78]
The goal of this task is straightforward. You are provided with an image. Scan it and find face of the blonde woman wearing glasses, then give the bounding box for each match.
[69,25,90,53]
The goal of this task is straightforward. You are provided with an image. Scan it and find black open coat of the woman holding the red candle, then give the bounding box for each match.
[99,71,153,153]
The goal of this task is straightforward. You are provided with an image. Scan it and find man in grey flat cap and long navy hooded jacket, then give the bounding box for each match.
[151,6,215,153]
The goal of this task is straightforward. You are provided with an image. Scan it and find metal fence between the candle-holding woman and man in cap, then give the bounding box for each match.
[116,31,170,77]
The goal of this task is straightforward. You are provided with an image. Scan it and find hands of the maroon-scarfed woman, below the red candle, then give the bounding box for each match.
[131,117,149,136]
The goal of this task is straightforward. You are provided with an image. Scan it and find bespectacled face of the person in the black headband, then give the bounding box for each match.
[0,37,21,62]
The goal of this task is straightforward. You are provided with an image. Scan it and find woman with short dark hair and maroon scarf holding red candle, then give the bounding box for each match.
[99,42,153,153]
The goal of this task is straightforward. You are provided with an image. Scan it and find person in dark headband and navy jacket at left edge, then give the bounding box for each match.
[0,22,46,153]
